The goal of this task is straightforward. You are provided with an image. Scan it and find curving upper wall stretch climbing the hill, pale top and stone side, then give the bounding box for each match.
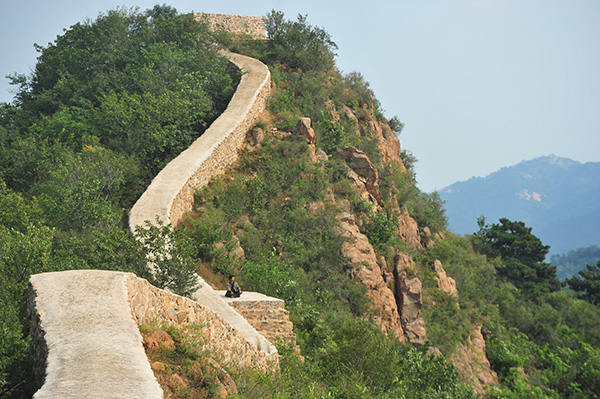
[129,53,271,231]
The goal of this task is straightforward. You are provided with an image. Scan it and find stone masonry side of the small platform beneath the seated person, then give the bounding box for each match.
[228,298,296,346]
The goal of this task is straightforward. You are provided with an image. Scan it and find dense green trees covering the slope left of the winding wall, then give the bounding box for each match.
[0,6,238,398]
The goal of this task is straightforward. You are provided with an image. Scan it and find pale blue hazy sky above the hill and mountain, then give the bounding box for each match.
[0,0,600,191]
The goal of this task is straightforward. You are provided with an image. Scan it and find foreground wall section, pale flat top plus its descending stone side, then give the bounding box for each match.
[28,270,279,399]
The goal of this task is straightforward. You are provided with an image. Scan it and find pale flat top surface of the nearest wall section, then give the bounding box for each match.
[30,270,163,399]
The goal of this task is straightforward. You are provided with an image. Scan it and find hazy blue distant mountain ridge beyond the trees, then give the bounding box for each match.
[439,155,600,254]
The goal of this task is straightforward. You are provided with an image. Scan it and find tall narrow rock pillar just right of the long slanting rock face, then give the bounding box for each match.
[393,253,427,345]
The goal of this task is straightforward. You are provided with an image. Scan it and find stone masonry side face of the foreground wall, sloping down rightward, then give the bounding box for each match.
[127,275,279,370]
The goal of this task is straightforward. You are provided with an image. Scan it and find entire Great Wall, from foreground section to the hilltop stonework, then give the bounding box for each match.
[28,14,295,398]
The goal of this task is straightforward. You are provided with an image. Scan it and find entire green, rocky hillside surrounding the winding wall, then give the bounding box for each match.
[0,6,600,398]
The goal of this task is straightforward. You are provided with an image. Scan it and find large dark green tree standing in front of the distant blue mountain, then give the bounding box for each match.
[473,217,560,296]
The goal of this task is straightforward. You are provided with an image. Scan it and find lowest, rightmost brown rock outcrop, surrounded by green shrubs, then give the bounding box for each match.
[450,325,498,395]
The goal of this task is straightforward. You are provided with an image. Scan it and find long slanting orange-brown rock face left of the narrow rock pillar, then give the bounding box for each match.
[338,213,405,341]
